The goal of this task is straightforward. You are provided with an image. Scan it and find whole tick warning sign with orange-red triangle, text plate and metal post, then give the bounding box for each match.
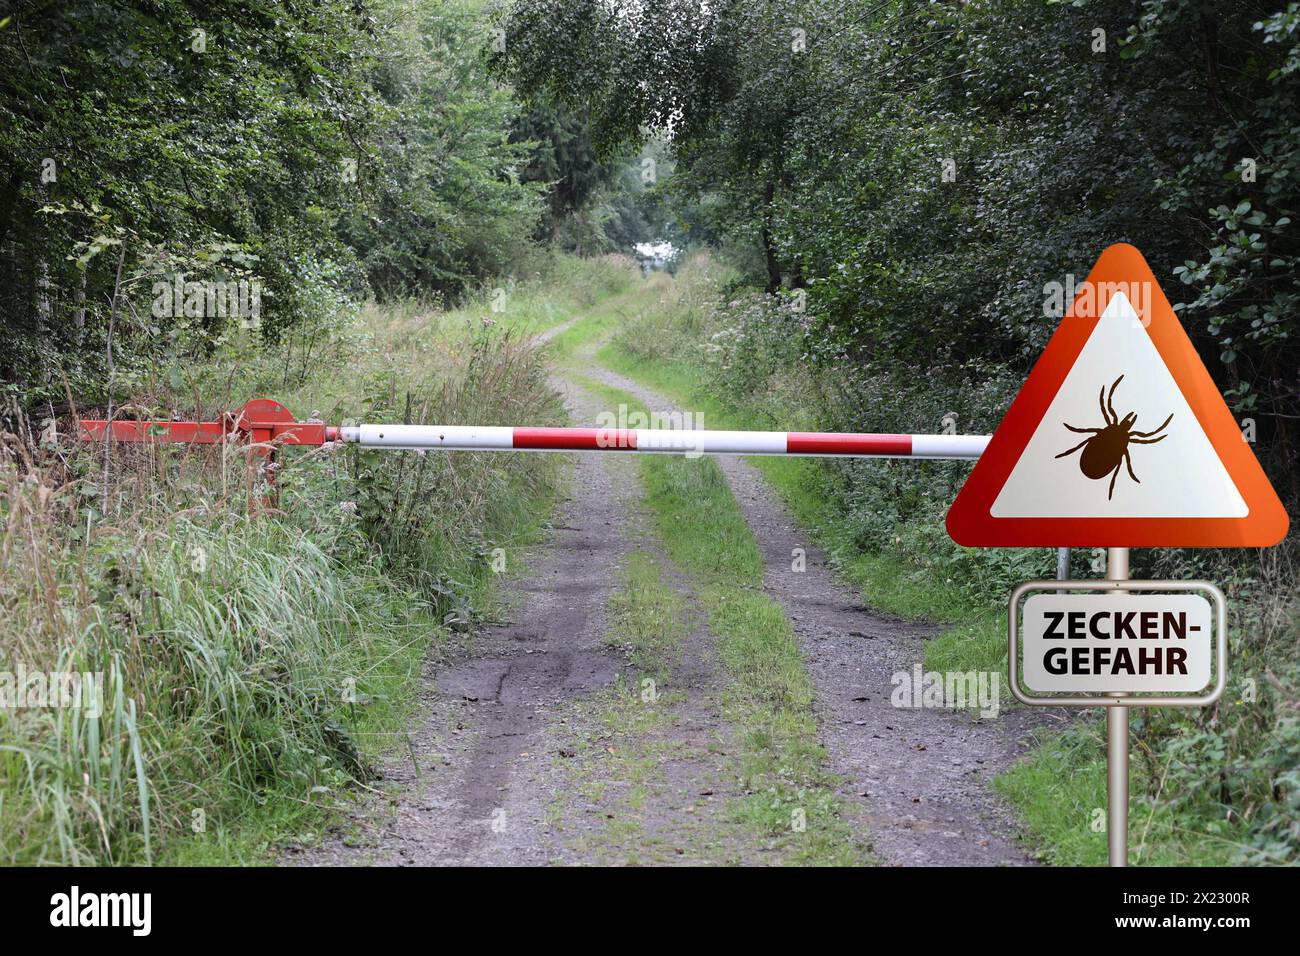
[948,245,1290,866]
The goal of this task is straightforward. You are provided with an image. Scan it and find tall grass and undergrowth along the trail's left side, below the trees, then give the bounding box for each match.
[0,259,634,864]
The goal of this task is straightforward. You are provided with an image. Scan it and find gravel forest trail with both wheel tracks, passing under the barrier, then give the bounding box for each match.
[290,291,1031,865]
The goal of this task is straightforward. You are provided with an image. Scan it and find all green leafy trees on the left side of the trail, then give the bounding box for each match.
[0,0,541,408]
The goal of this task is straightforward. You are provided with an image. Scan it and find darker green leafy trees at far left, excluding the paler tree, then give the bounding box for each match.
[0,0,377,403]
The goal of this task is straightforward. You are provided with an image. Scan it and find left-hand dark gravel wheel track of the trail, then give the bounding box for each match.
[299,374,634,866]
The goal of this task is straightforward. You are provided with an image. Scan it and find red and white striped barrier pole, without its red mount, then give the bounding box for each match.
[329,425,989,459]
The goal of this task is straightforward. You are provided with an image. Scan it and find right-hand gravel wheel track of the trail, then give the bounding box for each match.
[588,363,1036,865]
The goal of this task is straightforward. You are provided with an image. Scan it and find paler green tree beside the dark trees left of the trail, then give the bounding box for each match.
[339,0,542,300]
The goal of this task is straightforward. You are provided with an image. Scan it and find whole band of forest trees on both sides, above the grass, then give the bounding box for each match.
[0,0,1300,431]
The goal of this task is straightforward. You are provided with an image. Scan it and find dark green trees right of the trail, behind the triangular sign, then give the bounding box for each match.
[498,0,1300,498]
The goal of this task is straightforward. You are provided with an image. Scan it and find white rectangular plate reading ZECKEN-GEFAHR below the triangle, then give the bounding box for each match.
[1022,592,1214,693]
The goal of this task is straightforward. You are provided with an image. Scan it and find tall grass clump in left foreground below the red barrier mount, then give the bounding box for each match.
[0,476,434,864]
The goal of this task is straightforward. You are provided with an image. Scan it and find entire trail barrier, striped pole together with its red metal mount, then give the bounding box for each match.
[78,398,988,510]
